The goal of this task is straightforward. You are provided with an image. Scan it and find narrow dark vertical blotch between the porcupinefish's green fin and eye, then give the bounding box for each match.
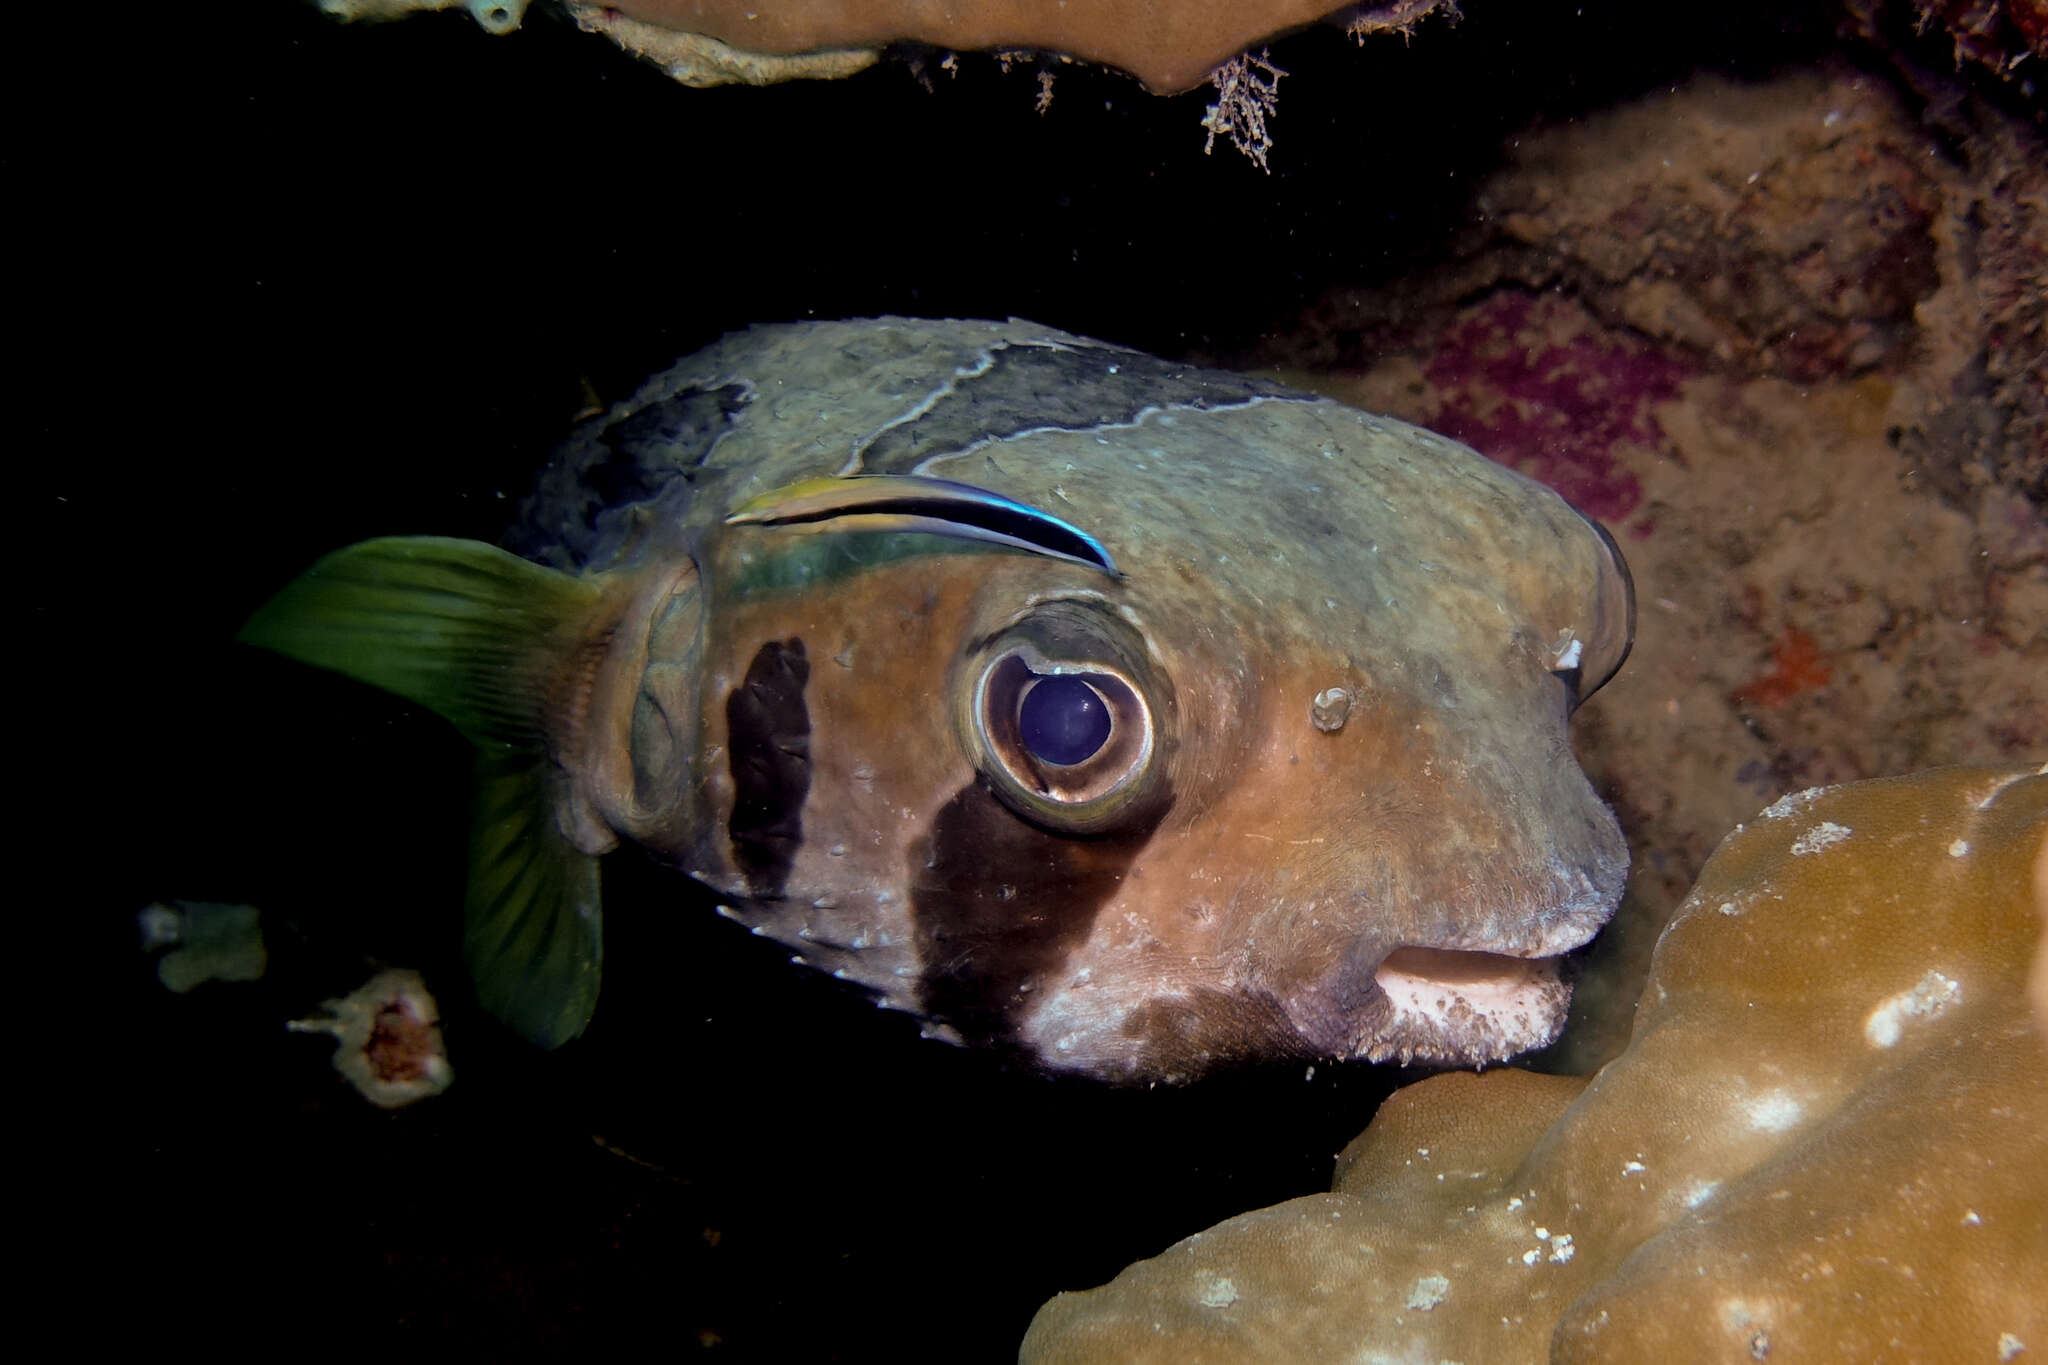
[725,641,811,896]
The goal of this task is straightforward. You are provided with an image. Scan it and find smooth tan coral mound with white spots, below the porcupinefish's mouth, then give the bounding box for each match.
[1024,767,2048,1365]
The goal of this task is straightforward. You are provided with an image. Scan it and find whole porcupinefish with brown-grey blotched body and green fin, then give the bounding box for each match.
[244,319,1634,1081]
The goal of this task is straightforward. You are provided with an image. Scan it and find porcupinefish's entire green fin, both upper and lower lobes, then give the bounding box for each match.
[240,536,602,1048]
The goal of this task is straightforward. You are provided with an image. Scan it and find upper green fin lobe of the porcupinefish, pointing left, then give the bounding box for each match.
[238,536,598,751]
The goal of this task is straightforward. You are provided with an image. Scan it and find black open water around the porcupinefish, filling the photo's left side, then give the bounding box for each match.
[32,0,1966,1361]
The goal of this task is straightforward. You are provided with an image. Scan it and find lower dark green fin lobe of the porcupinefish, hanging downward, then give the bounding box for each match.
[463,755,604,1048]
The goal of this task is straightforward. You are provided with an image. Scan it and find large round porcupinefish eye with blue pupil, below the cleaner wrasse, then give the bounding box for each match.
[961,602,1161,835]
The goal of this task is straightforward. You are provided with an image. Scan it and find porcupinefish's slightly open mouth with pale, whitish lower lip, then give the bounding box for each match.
[1358,945,1571,1066]
